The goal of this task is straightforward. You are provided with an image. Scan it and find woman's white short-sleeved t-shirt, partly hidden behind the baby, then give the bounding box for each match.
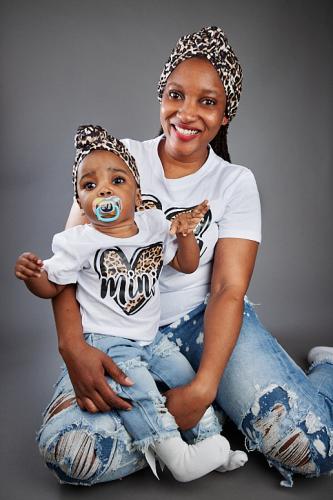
[123,136,261,325]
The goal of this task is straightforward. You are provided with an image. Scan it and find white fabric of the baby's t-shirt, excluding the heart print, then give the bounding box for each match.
[44,209,177,343]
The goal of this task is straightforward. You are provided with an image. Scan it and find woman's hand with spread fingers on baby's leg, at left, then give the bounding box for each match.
[61,341,133,413]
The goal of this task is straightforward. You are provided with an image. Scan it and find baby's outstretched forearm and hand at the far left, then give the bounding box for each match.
[15,252,64,299]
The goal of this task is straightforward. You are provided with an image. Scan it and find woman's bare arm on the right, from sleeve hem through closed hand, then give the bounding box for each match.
[166,238,258,430]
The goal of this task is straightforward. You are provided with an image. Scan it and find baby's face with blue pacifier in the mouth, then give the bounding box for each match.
[77,150,140,226]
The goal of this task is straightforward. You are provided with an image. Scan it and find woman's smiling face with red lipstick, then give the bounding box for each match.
[160,58,228,161]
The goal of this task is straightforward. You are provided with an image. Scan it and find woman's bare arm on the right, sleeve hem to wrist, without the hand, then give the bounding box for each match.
[197,238,258,390]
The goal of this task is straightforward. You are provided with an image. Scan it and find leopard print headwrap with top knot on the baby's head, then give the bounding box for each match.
[73,125,140,199]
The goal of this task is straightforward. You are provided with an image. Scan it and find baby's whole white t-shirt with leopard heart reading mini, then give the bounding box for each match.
[44,210,177,343]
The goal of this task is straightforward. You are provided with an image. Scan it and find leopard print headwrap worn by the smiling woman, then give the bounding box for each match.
[158,26,243,120]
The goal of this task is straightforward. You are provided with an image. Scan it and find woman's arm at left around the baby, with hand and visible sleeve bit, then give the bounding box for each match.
[52,202,132,413]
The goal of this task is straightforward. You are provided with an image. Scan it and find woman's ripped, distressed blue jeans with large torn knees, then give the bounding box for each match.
[38,300,333,486]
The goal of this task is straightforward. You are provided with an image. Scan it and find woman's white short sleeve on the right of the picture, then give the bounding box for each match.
[218,169,261,243]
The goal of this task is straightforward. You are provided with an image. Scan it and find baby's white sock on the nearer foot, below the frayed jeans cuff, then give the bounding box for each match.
[152,435,230,482]
